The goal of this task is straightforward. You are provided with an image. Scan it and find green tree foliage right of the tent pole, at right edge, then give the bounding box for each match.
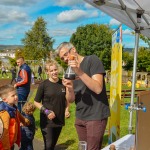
[137,47,150,72]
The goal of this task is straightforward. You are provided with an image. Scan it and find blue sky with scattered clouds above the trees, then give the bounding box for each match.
[0,0,147,48]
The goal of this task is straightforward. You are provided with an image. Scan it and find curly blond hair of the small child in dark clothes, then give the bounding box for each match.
[22,102,36,115]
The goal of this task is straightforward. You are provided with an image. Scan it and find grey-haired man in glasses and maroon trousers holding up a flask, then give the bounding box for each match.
[57,42,110,150]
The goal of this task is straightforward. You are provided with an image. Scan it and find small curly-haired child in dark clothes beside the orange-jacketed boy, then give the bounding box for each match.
[20,102,35,150]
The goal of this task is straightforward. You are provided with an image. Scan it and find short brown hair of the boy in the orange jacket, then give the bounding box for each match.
[0,84,16,99]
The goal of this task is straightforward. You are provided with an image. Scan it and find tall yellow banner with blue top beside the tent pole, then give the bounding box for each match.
[108,25,122,144]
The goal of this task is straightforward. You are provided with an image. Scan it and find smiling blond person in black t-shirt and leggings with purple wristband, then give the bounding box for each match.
[34,62,73,150]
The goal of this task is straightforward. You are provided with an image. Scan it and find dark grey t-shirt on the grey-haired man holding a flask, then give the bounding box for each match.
[74,55,110,120]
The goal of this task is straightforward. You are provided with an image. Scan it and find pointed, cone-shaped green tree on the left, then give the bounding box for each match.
[22,17,54,60]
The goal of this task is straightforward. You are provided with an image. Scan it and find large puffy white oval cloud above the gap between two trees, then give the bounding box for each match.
[57,9,87,22]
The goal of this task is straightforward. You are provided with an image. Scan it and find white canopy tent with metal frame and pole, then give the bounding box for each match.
[84,0,150,133]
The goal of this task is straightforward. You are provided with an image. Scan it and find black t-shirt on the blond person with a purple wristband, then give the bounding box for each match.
[35,79,66,128]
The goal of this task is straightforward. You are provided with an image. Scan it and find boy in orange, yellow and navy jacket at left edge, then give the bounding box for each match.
[0,85,30,150]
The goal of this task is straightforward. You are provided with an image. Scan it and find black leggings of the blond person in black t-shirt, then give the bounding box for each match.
[41,127,62,150]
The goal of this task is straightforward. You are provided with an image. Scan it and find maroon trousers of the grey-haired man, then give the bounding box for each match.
[75,118,107,150]
